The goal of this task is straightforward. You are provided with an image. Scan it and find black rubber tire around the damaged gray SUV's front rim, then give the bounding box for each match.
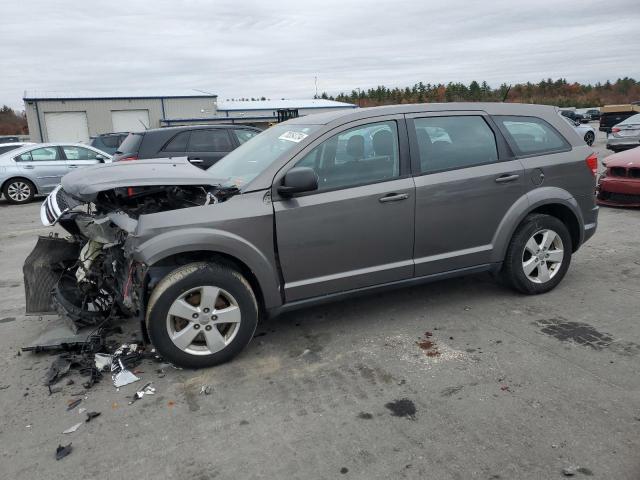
[146,262,258,368]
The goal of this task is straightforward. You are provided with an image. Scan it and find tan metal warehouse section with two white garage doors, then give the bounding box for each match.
[24,91,217,142]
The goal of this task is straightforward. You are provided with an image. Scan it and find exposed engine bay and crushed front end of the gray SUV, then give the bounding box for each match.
[23,185,238,331]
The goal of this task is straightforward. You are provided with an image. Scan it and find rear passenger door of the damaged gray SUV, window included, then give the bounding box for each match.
[407,111,526,277]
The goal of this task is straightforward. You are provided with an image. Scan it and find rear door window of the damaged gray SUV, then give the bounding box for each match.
[414,115,498,173]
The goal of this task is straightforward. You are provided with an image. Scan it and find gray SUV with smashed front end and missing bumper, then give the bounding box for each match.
[25,103,598,367]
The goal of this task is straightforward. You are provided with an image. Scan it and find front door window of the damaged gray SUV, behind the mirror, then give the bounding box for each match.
[296,121,400,191]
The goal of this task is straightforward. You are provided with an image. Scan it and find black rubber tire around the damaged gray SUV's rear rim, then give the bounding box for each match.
[503,214,572,295]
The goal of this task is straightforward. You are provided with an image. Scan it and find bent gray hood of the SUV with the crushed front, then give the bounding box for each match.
[61,157,220,202]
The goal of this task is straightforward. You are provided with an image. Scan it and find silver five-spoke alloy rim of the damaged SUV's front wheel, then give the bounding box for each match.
[167,285,241,355]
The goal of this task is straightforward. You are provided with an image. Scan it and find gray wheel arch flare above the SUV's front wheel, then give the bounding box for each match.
[132,228,282,308]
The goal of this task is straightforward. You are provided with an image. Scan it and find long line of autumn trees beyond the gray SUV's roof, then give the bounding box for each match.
[316,77,640,108]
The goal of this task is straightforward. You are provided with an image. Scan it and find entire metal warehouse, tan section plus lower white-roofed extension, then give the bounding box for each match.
[24,90,356,142]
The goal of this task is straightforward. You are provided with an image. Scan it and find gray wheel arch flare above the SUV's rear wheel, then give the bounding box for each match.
[491,187,584,263]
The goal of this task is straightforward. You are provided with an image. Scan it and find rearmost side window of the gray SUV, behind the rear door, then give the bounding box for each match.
[493,115,571,155]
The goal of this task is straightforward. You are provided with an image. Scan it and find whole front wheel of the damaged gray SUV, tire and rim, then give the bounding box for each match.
[146,262,258,368]
